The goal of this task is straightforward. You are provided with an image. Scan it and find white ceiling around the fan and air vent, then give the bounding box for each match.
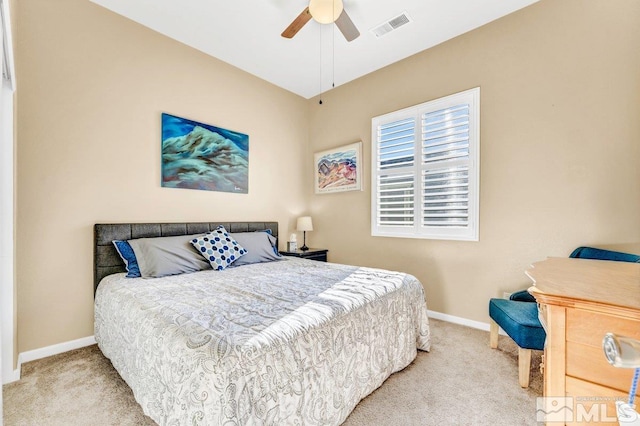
[91,0,538,98]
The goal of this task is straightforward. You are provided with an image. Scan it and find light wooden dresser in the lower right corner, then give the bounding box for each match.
[526,258,640,425]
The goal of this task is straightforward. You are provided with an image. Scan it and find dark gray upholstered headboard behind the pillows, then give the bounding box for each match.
[93,222,278,292]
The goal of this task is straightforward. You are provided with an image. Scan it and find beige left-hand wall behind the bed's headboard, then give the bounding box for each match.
[14,0,308,352]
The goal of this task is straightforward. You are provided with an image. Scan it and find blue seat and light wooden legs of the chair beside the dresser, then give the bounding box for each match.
[489,299,547,388]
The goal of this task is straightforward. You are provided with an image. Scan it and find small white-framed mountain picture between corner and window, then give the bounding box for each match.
[314,142,362,194]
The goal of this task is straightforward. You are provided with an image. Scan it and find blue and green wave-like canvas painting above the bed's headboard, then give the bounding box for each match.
[162,113,249,194]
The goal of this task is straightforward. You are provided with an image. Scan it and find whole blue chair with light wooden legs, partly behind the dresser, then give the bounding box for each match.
[489,247,640,388]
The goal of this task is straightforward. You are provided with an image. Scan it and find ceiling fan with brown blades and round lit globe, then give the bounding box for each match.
[282,0,360,41]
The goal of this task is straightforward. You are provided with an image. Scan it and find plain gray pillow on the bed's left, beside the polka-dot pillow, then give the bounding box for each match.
[128,234,211,278]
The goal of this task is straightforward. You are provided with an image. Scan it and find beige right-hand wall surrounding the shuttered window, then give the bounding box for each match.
[306,0,640,322]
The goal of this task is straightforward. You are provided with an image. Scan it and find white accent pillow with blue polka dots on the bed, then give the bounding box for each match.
[191,225,247,271]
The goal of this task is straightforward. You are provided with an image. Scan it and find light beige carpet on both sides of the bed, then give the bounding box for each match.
[3,320,542,426]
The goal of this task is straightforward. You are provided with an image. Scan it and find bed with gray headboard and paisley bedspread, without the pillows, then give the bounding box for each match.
[94,222,430,425]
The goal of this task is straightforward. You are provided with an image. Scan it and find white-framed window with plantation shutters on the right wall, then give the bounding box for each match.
[371,87,480,241]
